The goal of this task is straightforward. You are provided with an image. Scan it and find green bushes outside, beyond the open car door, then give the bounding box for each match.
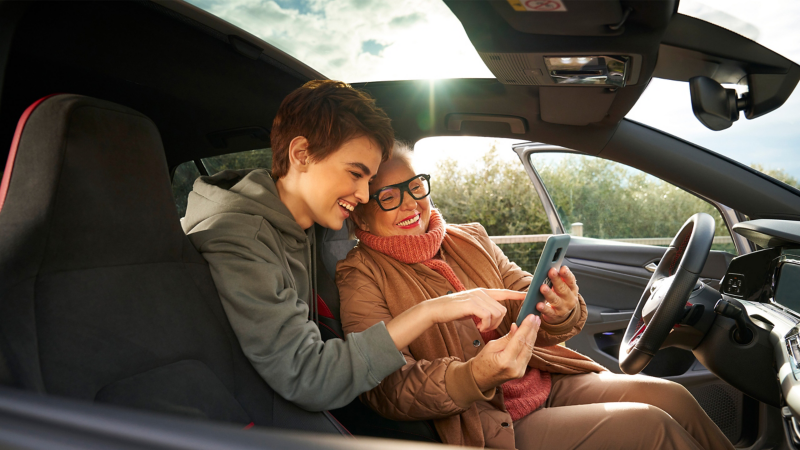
[431,146,734,270]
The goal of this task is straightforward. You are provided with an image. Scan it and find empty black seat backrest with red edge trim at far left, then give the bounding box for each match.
[0,94,342,433]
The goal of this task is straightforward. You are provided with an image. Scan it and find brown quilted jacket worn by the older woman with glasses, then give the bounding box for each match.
[336,220,604,448]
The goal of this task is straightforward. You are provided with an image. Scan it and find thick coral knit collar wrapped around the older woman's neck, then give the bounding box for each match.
[356,209,445,264]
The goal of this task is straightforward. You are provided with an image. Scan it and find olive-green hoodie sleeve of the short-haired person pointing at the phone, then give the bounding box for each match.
[189,217,406,411]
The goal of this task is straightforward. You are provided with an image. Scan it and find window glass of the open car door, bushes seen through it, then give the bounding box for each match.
[530,153,737,255]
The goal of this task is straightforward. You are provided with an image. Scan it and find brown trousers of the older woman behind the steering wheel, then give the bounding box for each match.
[514,372,733,450]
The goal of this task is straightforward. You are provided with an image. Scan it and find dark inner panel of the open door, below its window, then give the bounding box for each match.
[565,237,744,442]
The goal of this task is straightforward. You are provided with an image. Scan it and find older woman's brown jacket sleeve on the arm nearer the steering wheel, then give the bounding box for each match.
[473,224,588,347]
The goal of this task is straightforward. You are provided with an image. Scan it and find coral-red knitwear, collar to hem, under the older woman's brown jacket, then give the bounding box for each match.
[356,209,551,420]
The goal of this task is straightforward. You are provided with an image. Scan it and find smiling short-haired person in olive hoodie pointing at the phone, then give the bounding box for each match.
[182,80,536,411]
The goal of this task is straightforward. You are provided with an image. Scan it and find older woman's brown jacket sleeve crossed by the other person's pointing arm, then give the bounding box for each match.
[336,262,494,420]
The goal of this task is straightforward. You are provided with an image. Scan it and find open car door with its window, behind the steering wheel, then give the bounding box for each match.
[514,145,757,443]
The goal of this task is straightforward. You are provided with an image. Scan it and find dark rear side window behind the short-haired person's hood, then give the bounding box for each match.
[172,148,272,217]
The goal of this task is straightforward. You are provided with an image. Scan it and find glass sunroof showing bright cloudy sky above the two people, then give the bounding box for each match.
[189,0,494,83]
